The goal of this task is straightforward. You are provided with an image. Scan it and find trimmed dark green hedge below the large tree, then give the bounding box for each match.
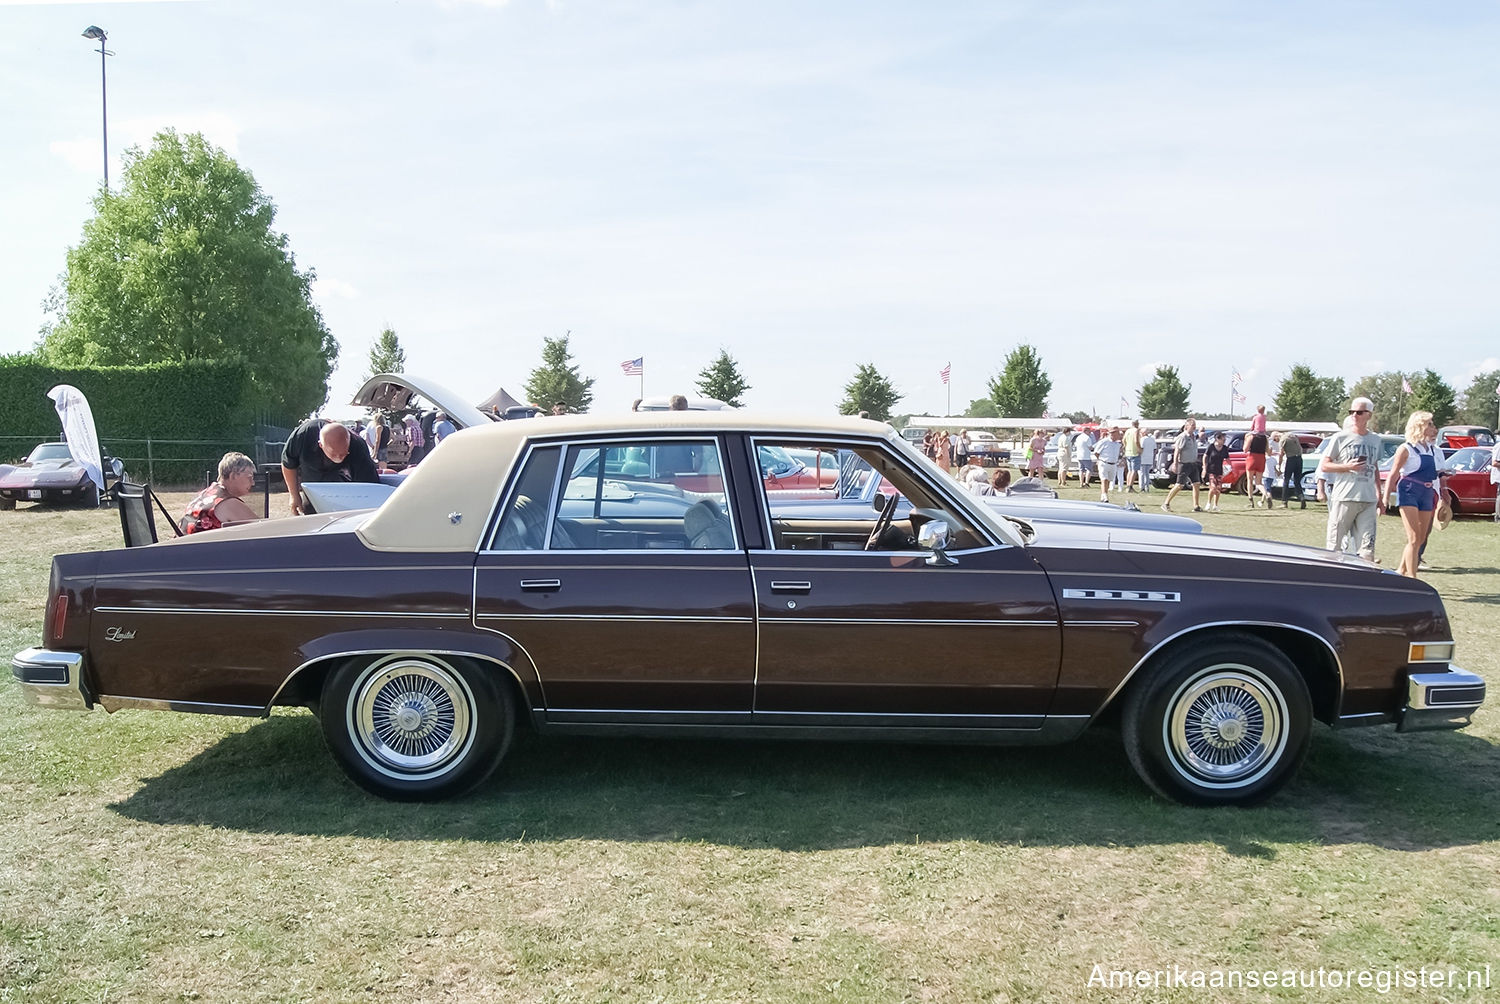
[0,356,257,483]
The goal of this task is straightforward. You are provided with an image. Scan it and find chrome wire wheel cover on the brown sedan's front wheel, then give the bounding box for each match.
[1161,663,1289,788]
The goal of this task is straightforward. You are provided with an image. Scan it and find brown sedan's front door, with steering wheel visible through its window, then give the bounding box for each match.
[750,443,1061,728]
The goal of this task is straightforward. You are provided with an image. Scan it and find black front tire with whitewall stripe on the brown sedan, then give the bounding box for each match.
[1125,635,1313,806]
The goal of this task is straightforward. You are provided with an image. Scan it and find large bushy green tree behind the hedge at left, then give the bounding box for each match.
[41,129,339,420]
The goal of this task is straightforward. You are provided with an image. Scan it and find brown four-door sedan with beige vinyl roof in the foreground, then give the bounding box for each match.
[12,411,1485,804]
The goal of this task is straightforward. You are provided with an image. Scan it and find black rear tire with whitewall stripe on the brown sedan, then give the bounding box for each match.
[320,653,515,801]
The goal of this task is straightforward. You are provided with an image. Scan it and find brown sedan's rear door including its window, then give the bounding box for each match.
[474,437,755,723]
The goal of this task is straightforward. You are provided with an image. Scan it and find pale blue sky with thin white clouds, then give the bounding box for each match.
[0,0,1500,416]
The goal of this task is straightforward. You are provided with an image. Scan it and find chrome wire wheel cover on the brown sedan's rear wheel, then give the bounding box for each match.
[348,656,474,780]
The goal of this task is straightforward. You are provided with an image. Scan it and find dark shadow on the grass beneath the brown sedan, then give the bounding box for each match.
[113,716,1500,857]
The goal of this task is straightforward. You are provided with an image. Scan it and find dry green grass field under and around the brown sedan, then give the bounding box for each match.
[0,489,1500,1002]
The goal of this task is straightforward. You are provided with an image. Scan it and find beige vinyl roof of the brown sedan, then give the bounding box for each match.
[357,411,912,552]
